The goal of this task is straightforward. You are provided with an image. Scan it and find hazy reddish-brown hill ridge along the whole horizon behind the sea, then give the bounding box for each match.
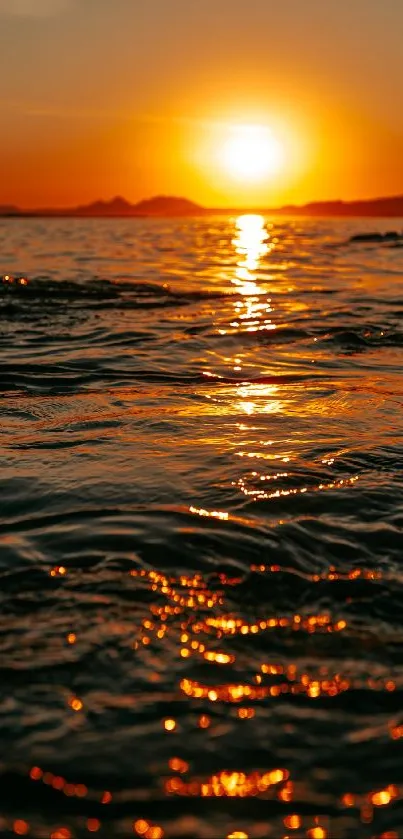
[0,195,403,218]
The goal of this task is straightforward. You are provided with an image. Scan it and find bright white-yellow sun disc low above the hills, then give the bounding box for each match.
[220,125,284,182]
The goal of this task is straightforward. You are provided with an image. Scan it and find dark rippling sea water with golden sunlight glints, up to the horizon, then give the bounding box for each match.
[0,217,403,839]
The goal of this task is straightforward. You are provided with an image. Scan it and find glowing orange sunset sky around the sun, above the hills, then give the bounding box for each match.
[0,0,403,206]
